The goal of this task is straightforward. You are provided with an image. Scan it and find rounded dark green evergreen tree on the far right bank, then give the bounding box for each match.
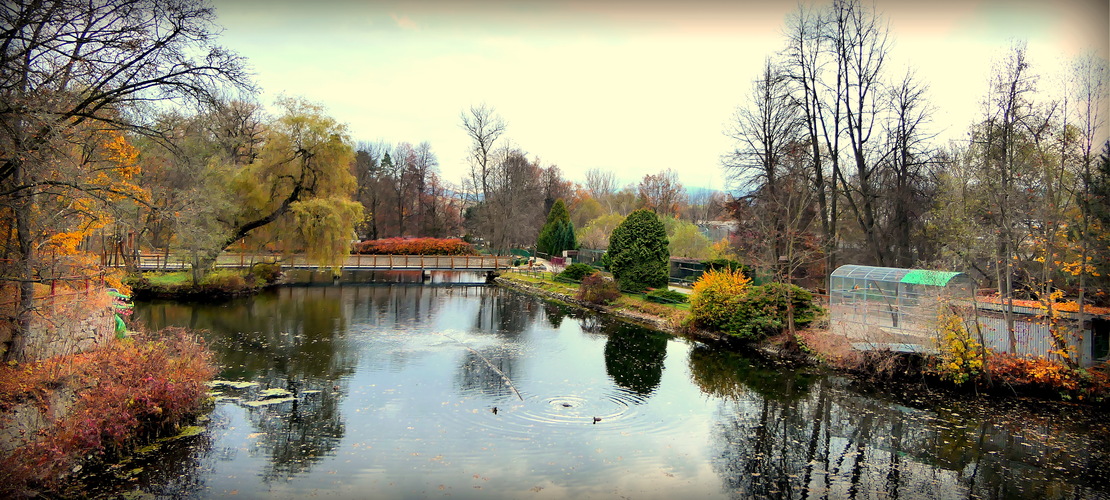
[608,209,670,291]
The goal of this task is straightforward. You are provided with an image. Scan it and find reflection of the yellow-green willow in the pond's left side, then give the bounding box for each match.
[137,287,359,480]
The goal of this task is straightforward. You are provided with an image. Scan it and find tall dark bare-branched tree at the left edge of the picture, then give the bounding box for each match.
[0,0,245,360]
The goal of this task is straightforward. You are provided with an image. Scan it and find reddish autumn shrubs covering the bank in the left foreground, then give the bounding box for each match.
[0,329,215,498]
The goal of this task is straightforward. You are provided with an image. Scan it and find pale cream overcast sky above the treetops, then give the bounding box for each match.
[206,0,1110,189]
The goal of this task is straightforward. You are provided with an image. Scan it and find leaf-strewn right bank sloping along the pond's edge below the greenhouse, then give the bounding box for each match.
[495,273,1110,410]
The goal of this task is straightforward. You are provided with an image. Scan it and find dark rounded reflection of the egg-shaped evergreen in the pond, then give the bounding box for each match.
[605,321,669,397]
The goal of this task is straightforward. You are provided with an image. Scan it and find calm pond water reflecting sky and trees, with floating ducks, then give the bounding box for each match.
[117,279,1110,499]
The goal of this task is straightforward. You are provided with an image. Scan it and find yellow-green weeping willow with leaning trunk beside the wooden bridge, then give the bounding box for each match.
[179,98,362,279]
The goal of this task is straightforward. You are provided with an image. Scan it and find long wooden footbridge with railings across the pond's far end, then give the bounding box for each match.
[139,253,513,271]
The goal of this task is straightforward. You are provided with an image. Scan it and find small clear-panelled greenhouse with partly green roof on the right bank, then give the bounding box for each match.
[829,266,976,350]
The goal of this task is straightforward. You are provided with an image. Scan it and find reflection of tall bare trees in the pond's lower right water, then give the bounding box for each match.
[690,348,1110,499]
